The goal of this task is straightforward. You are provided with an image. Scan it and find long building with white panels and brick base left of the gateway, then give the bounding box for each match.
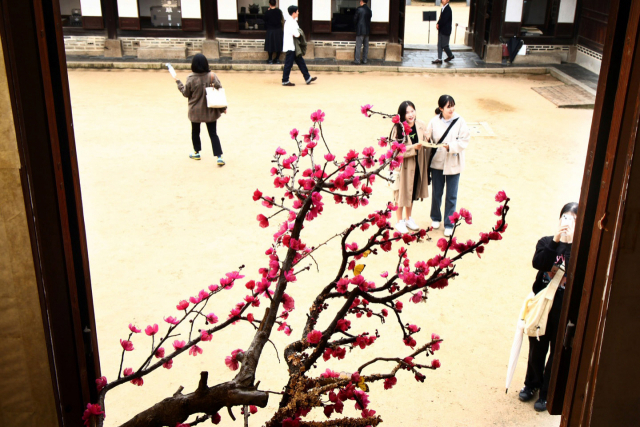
[60,0,405,60]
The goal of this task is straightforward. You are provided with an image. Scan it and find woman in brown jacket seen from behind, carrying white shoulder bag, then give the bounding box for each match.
[175,53,227,166]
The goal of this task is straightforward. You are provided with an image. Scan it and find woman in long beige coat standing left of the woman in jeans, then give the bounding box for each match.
[391,101,431,234]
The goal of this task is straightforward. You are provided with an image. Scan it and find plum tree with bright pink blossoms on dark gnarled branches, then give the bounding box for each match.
[83,105,509,427]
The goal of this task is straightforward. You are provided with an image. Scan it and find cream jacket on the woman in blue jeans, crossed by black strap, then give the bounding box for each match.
[426,113,470,175]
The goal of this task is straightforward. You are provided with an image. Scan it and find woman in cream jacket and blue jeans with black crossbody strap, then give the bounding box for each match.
[427,95,469,237]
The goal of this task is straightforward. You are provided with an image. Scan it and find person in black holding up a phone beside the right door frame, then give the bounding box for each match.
[518,203,578,412]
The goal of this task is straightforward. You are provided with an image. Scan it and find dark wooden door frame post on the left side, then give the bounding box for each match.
[0,0,100,426]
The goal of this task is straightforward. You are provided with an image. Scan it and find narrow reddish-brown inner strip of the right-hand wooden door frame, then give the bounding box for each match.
[548,0,640,426]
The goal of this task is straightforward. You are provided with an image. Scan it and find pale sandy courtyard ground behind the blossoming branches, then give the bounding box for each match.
[70,71,592,427]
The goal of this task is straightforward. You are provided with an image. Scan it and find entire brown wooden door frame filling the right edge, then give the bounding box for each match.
[548,0,640,427]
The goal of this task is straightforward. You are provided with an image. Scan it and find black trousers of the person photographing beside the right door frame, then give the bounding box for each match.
[524,288,564,400]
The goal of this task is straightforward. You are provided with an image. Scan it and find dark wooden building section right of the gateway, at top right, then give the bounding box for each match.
[466,0,611,73]
